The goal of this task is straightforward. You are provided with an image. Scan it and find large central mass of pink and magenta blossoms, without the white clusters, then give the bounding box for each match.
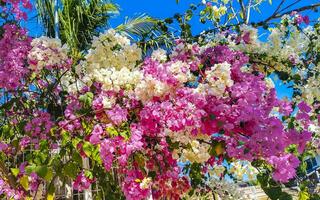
[56,44,311,199]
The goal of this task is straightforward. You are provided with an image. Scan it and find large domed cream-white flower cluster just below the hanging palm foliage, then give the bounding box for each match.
[78,29,143,91]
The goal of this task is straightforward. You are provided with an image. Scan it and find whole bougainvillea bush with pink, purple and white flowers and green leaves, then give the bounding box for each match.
[0,1,320,199]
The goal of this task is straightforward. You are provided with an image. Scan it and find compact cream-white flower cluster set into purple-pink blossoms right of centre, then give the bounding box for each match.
[197,62,233,97]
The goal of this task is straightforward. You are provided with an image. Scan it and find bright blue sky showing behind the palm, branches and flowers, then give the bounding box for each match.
[24,0,320,98]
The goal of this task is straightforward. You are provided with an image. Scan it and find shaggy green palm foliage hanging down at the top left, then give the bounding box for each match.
[37,0,119,57]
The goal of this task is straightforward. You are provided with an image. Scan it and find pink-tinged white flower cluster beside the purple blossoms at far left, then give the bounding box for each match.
[28,36,70,71]
